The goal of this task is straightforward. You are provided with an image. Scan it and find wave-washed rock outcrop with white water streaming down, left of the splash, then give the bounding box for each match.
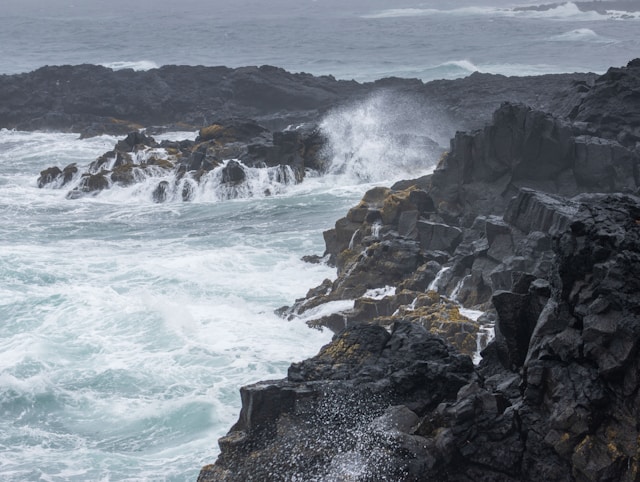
[37,118,327,202]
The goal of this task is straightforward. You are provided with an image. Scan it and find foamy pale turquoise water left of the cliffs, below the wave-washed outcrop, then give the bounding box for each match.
[0,130,344,481]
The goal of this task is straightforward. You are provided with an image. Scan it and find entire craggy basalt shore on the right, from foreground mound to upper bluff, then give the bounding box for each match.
[199,61,640,482]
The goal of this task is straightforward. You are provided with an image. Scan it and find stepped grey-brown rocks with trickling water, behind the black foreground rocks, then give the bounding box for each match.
[280,59,640,360]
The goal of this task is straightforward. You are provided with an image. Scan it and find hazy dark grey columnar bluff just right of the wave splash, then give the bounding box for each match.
[429,103,640,225]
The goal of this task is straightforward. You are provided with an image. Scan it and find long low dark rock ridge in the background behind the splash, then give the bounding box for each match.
[0,65,595,136]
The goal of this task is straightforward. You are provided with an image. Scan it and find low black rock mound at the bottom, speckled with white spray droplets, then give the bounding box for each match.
[198,323,475,482]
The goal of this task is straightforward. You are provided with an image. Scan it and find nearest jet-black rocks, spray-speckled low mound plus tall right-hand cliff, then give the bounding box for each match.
[199,194,640,481]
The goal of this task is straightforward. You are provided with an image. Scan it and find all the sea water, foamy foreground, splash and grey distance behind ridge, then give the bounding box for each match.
[0,0,640,481]
